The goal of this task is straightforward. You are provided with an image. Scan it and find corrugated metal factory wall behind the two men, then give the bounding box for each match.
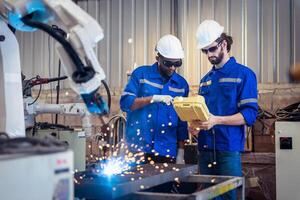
[17,0,300,91]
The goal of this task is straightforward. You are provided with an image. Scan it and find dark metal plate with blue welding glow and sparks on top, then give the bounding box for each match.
[75,163,198,199]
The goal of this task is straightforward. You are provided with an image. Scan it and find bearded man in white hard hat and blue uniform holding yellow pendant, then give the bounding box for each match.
[189,20,258,199]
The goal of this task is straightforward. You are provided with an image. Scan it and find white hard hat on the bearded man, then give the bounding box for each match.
[196,20,224,49]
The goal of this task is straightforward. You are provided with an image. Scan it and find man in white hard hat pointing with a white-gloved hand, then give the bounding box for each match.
[120,35,189,164]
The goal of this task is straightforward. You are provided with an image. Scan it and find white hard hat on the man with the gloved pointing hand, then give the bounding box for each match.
[155,35,184,59]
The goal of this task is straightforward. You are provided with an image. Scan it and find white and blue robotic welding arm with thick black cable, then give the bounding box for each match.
[0,0,108,138]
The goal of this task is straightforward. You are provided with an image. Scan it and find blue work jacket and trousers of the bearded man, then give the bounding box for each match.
[198,57,258,199]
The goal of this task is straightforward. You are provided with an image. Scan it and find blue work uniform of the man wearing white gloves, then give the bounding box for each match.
[120,63,189,158]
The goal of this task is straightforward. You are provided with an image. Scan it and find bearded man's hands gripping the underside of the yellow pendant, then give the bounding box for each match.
[189,114,219,135]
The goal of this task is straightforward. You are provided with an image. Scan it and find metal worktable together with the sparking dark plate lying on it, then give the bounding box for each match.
[75,164,244,200]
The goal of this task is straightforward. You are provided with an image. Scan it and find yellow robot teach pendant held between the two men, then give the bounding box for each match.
[173,95,209,122]
